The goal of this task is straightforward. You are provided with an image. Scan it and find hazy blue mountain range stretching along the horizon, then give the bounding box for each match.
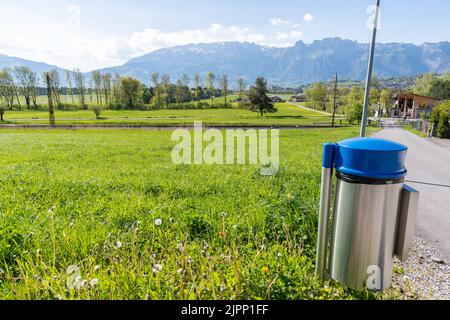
[0,38,450,86]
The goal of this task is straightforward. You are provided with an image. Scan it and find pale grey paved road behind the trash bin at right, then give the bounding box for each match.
[375,128,450,259]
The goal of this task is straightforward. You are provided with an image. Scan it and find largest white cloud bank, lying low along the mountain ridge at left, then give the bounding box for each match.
[0,23,303,71]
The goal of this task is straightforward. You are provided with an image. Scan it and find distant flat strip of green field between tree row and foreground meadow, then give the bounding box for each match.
[4,103,345,126]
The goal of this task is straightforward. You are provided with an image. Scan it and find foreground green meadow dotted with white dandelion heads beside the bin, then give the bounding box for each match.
[0,128,398,299]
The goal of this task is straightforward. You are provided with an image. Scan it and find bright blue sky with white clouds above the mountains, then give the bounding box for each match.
[0,0,450,71]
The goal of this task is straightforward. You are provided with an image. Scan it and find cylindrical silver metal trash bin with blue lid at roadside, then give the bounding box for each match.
[316,138,419,290]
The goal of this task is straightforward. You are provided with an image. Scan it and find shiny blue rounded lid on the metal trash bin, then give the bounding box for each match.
[334,138,408,179]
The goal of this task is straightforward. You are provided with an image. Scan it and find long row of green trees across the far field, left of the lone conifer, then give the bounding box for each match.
[0,67,253,110]
